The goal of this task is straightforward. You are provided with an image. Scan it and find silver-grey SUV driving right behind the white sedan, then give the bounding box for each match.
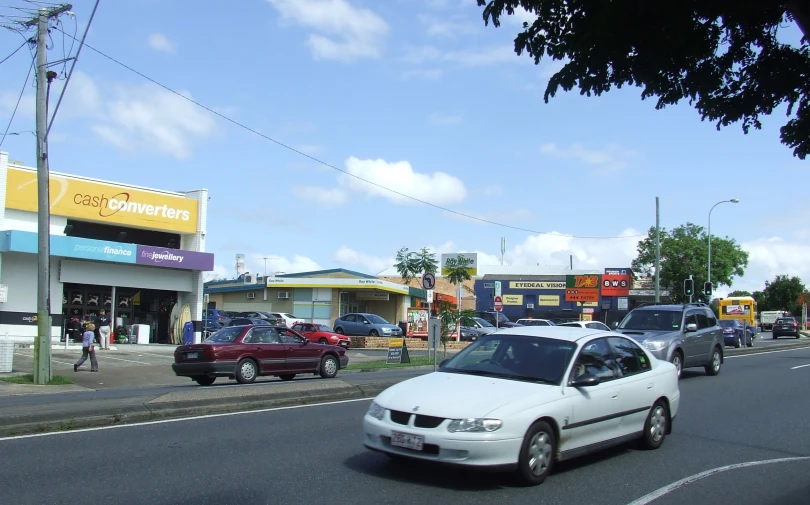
[613,303,724,377]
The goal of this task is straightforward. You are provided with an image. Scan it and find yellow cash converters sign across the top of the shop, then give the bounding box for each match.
[6,167,197,233]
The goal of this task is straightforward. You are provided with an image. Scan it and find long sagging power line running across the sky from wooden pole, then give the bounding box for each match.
[50,27,647,239]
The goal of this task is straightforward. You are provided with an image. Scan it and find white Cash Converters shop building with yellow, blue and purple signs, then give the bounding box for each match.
[0,152,214,343]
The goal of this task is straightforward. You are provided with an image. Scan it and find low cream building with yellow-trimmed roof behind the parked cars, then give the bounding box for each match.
[205,268,427,326]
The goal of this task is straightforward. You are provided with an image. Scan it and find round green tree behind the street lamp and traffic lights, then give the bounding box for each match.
[632,223,748,303]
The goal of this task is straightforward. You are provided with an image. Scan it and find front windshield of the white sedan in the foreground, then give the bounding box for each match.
[440,333,576,385]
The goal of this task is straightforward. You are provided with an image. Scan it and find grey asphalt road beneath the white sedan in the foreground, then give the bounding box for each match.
[0,349,810,505]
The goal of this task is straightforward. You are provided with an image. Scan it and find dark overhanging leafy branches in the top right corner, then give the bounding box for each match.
[478,0,810,159]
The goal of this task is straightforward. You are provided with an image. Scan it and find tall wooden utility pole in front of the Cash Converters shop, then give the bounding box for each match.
[26,4,73,384]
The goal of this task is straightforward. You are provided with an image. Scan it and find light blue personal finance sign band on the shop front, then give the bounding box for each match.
[2,230,137,264]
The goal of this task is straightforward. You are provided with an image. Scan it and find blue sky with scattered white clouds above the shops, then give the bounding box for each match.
[0,0,810,296]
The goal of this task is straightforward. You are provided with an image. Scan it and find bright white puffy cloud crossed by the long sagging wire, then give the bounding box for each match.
[338,156,467,205]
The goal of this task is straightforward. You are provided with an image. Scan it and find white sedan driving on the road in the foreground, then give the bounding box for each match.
[363,326,680,485]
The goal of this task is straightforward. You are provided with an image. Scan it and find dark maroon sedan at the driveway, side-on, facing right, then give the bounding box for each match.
[172,325,349,386]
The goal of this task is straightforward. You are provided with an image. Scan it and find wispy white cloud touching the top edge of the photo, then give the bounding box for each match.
[267,0,389,62]
